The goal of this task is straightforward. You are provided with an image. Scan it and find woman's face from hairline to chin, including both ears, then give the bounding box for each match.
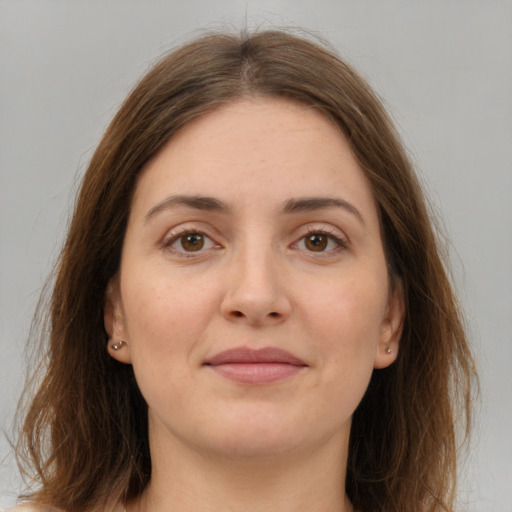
[105,99,403,456]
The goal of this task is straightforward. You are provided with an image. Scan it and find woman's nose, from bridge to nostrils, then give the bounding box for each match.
[221,247,291,326]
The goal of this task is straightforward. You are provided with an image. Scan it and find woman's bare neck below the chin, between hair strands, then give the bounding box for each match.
[131,426,353,512]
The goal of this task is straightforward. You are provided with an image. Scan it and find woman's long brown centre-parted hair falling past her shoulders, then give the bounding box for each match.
[14,31,474,512]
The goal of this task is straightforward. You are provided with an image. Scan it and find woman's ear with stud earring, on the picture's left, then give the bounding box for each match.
[103,278,132,364]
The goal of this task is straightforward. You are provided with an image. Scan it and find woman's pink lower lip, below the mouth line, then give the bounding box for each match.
[210,363,305,384]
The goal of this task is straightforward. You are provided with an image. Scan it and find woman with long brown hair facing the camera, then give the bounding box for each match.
[13,31,474,512]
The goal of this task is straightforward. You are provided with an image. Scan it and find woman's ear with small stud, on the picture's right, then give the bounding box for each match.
[374,279,405,368]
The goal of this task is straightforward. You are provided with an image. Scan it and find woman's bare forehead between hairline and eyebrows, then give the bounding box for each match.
[133,98,374,221]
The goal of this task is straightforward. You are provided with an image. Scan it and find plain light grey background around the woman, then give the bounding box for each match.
[0,0,512,512]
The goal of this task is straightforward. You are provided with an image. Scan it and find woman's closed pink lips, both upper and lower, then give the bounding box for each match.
[205,347,308,384]
